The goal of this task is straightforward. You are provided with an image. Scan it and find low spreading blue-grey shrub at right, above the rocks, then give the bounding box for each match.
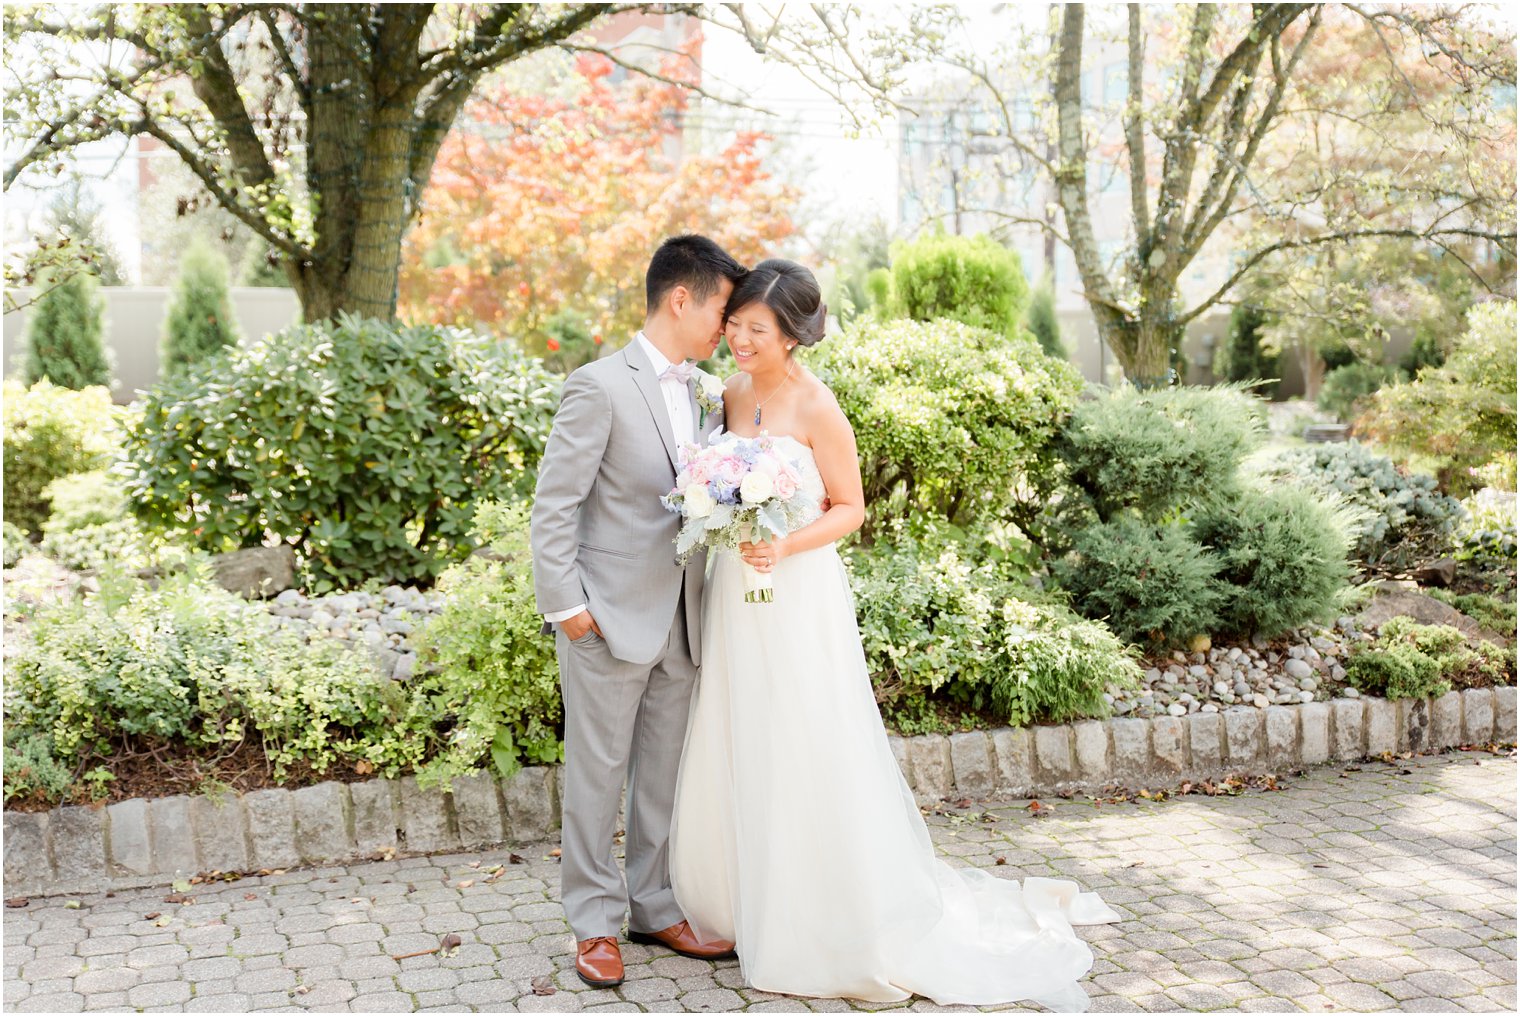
[1266,441,1462,570]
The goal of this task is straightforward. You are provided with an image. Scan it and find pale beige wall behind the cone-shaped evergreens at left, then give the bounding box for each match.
[3,286,301,403]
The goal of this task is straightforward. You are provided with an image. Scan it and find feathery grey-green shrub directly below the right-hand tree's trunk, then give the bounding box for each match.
[1056,386,1266,522]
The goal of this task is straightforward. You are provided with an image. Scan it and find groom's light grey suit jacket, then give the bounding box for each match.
[532,344,720,665]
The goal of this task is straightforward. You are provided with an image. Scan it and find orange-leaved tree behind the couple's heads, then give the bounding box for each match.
[400,55,796,367]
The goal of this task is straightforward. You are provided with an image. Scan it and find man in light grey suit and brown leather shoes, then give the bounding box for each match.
[532,236,745,987]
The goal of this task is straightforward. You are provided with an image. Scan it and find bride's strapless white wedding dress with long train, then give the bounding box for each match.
[670,438,1119,1011]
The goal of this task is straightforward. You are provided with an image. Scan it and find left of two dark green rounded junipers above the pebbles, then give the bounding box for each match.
[1050,516,1225,645]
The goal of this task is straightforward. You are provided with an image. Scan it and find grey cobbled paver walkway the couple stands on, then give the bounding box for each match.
[5,753,1515,1013]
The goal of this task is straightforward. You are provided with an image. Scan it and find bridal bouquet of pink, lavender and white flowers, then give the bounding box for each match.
[660,435,809,604]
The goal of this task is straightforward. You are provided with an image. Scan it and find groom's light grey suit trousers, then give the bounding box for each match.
[556,590,696,940]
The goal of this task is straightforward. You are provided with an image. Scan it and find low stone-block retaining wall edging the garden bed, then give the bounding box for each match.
[5,687,1515,896]
